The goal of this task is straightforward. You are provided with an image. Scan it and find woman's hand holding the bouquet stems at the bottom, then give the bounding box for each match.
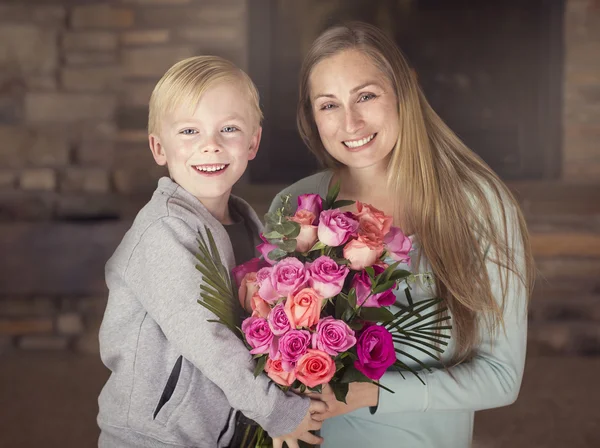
[308,383,379,420]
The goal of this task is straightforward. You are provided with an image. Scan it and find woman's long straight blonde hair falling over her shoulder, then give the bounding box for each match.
[297,22,534,363]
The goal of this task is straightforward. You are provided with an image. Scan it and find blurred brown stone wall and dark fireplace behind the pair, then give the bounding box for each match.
[0,0,600,448]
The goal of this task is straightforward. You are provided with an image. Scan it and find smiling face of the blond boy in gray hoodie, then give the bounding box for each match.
[149,81,262,207]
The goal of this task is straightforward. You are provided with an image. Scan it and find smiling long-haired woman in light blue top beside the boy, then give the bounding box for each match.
[271,23,533,448]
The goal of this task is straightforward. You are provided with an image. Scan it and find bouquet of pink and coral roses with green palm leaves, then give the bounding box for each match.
[198,185,450,448]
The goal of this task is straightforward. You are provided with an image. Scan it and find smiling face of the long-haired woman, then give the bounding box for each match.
[309,50,400,169]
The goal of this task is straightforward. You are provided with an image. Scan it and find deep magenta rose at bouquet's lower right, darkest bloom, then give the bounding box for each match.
[354,325,396,380]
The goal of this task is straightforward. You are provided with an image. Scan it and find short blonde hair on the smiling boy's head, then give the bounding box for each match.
[148,56,263,134]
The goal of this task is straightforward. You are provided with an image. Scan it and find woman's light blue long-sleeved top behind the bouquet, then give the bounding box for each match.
[270,171,527,448]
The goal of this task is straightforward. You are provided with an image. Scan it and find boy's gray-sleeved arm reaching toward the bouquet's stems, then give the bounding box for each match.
[125,217,309,436]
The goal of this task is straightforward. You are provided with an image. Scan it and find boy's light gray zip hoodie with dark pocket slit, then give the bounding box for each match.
[98,177,309,448]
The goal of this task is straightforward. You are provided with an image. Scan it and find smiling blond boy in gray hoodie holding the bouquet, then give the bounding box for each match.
[98,56,326,448]
